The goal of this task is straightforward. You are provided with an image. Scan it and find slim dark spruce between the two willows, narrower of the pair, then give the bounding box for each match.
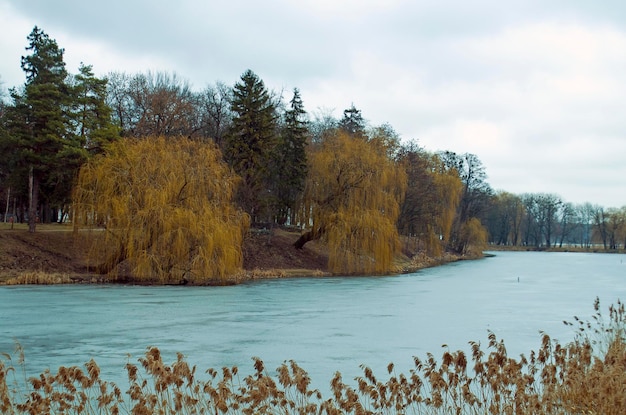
[275,88,308,223]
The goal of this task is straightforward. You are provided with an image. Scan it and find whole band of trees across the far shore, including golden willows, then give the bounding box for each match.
[0,27,626,282]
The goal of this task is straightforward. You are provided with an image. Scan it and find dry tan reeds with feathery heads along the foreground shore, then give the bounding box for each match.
[0,299,626,415]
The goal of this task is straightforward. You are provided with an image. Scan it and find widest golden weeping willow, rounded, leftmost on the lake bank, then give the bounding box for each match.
[73,137,249,284]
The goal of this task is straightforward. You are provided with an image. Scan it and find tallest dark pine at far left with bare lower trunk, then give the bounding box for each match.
[4,26,86,232]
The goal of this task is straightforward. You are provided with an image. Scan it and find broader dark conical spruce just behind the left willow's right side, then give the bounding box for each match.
[225,70,277,222]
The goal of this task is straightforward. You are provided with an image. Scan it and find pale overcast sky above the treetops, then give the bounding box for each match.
[0,0,626,208]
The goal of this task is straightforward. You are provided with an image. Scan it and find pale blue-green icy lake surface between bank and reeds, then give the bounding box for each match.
[0,252,626,390]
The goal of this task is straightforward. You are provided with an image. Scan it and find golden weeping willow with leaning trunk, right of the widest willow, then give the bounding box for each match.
[294,130,406,274]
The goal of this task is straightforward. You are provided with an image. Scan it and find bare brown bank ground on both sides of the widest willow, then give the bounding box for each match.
[0,223,328,284]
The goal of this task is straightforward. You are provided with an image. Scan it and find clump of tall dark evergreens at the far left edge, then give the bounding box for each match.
[0,27,118,232]
